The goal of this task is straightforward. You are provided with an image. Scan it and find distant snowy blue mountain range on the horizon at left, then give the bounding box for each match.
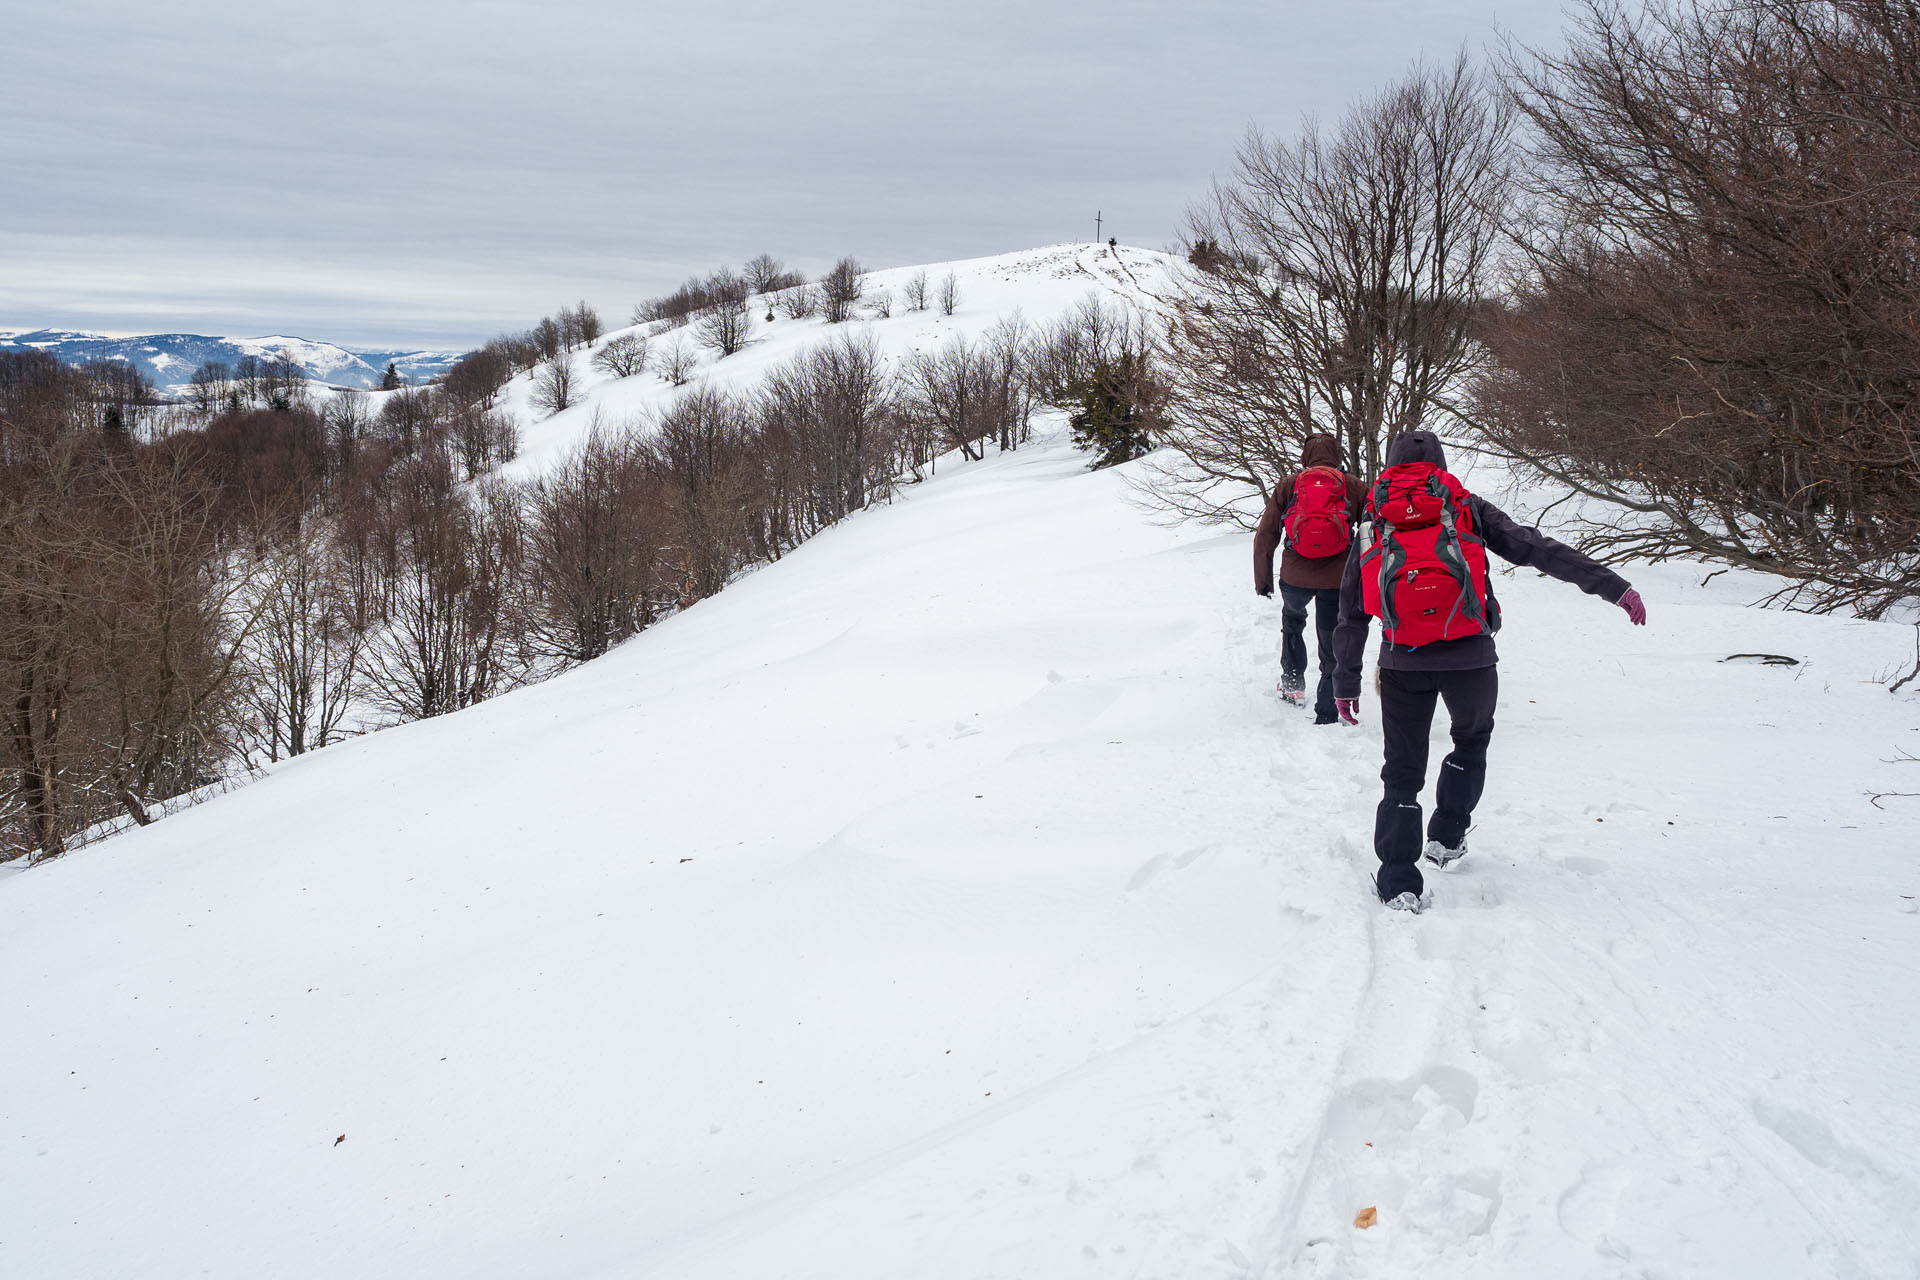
[0,328,465,393]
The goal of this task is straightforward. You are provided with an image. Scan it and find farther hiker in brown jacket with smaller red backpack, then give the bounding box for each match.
[1254,434,1367,723]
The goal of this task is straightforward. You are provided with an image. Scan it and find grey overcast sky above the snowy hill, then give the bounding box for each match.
[0,0,1561,347]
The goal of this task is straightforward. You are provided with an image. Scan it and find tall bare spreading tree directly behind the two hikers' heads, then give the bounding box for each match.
[1154,56,1513,520]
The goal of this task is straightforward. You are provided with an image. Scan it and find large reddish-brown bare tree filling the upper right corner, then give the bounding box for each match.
[1476,0,1920,616]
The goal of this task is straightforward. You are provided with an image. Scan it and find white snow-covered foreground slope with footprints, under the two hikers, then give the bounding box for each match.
[0,433,1920,1280]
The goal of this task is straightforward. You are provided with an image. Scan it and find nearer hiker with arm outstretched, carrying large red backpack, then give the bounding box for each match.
[1334,432,1647,912]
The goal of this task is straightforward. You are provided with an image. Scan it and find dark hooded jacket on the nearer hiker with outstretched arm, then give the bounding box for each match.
[1332,432,1628,699]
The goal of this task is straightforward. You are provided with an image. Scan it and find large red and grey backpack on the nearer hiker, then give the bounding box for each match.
[1359,462,1500,647]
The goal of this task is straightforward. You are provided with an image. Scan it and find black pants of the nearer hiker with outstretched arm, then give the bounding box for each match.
[1373,666,1500,902]
